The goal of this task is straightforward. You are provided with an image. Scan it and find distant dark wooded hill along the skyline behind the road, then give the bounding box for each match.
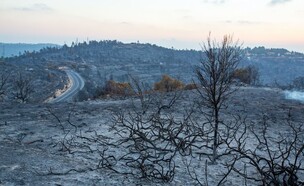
[0,40,304,102]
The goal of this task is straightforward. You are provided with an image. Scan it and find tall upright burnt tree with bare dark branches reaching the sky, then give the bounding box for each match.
[196,35,241,162]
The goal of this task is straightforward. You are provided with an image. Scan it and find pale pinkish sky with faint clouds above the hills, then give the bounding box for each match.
[0,0,304,52]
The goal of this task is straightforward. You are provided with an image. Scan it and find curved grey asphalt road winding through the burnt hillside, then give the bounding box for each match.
[50,69,84,103]
